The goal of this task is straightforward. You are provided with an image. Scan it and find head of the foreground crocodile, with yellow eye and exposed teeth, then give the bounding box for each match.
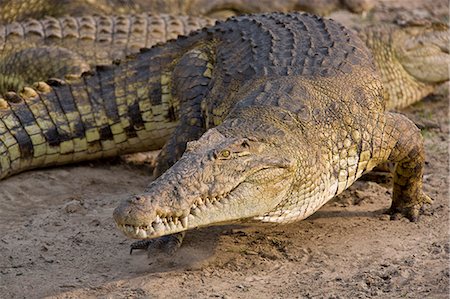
[114,115,296,238]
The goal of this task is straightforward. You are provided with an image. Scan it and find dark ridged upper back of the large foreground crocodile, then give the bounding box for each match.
[212,13,375,80]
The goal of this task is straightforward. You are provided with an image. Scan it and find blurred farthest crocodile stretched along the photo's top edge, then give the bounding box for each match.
[0,0,375,24]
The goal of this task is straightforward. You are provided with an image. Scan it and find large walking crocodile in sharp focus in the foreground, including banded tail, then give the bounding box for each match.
[0,13,429,251]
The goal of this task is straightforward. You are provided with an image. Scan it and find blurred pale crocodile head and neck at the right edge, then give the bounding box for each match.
[359,22,450,109]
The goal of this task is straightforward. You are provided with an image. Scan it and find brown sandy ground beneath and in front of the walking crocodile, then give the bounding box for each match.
[0,1,450,298]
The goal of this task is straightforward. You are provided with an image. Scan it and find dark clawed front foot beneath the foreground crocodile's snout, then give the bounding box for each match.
[130,232,185,257]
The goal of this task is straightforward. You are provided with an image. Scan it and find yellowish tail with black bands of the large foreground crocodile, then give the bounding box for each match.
[0,66,176,178]
